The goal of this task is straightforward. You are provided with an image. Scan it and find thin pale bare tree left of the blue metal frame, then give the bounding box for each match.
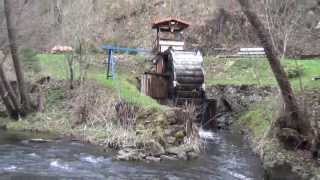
[56,0,99,89]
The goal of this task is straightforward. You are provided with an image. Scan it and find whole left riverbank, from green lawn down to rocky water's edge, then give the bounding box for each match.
[1,52,202,162]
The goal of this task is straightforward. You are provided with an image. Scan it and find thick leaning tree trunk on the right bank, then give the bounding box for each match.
[238,0,306,133]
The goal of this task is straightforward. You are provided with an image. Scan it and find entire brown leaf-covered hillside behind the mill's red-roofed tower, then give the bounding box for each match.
[0,0,320,55]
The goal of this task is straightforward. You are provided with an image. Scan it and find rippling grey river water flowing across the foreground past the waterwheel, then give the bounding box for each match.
[0,131,263,180]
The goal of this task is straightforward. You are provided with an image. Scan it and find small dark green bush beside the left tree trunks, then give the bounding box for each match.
[20,48,41,73]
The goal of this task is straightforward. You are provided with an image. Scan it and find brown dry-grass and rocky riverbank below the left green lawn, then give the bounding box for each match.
[2,81,201,162]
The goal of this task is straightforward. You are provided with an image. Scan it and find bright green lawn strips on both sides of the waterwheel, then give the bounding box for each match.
[38,54,320,108]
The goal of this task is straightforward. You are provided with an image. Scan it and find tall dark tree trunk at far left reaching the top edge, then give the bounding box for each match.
[4,0,32,113]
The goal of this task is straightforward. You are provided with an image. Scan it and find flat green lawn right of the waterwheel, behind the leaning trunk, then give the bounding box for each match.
[204,57,320,89]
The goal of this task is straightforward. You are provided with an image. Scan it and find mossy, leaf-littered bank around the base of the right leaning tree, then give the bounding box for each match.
[234,90,320,180]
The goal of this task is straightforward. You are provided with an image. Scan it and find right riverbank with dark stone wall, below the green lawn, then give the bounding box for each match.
[207,82,320,180]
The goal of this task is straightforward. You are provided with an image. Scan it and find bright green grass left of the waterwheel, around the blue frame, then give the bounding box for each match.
[38,54,161,108]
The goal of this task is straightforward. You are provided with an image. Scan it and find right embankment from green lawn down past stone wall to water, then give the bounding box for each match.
[206,58,320,179]
